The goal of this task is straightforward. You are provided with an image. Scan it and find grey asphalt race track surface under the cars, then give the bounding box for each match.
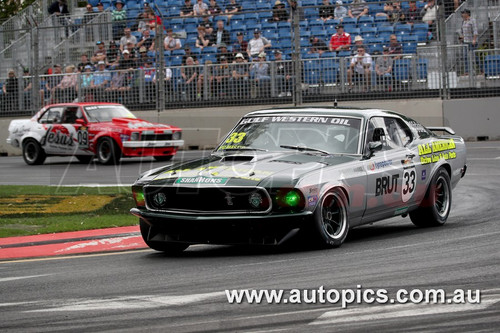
[0,142,500,332]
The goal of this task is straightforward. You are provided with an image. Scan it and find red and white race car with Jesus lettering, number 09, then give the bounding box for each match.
[7,103,184,165]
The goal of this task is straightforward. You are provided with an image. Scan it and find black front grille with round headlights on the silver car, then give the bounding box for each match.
[144,186,271,214]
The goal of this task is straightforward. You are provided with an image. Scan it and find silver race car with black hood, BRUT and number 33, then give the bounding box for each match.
[131,107,466,252]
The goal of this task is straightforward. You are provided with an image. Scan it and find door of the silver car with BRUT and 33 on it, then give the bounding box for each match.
[363,117,416,222]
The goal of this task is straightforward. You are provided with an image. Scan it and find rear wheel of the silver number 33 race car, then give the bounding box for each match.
[410,168,451,227]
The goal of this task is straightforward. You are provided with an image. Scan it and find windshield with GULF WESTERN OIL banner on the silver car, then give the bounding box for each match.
[216,116,361,154]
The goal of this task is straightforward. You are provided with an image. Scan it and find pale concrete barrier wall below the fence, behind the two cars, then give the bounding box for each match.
[0,99,494,155]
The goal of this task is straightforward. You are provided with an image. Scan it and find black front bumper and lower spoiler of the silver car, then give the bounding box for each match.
[130,208,313,245]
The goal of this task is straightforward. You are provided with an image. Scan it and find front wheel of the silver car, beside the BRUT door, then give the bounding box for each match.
[314,190,349,248]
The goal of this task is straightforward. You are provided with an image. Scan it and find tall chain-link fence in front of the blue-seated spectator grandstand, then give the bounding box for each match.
[0,0,500,116]
